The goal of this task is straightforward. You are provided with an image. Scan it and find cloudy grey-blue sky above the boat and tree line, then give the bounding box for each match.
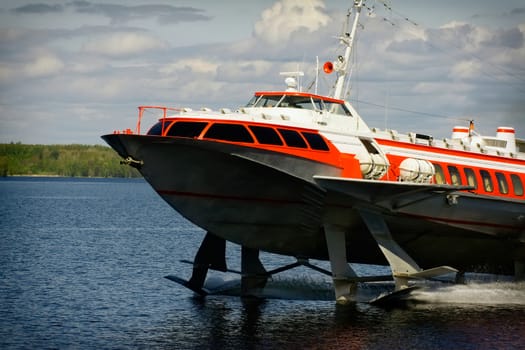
[0,0,525,144]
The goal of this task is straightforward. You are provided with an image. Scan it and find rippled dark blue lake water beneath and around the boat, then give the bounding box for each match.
[0,178,525,349]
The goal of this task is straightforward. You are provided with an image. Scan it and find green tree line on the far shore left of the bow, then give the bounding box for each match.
[0,143,141,178]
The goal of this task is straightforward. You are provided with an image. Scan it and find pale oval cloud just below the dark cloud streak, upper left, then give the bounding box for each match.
[82,32,168,57]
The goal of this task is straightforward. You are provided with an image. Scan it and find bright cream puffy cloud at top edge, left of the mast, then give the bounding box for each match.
[254,0,330,45]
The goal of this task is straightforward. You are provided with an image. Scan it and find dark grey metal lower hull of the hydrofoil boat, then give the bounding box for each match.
[103,134,525,273]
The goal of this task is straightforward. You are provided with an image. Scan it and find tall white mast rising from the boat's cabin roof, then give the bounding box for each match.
[333,0,363,99]
